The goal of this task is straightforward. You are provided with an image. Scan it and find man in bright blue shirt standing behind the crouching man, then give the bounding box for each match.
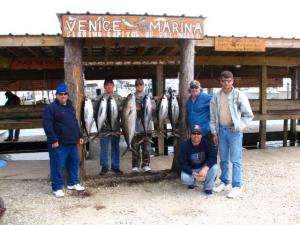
[187,80,212,141]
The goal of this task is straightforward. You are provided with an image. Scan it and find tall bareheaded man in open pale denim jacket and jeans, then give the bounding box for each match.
[210,71,253,198]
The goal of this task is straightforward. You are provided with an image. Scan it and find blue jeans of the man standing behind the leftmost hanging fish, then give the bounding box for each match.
[100,136,120,169]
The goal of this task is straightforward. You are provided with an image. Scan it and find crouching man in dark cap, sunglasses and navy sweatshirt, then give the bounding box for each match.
[179,124,218,195]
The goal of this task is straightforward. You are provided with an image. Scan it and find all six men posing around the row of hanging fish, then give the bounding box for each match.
[43,71,253,198]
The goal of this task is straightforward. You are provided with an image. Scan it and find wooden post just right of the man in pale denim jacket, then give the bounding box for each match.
[259,66,267,149]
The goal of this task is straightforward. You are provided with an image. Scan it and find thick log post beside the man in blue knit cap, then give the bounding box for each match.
[64,39,85,179]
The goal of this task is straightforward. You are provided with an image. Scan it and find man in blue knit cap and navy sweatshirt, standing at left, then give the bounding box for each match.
[43,83,85,198]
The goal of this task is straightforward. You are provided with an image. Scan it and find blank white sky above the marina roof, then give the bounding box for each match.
[0,0,300,38]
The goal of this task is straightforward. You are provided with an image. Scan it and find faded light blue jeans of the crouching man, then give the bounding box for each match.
[181,164,218,190]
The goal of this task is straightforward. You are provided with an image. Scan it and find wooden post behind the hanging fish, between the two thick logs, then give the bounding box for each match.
[155,64,165,155]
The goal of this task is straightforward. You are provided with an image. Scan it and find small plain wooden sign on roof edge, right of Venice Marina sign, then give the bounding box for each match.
[215,37,266,52]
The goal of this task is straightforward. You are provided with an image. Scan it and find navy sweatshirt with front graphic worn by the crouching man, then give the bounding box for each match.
[179,138,217,174]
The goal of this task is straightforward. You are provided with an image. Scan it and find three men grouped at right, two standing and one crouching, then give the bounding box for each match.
[179,71,253,198]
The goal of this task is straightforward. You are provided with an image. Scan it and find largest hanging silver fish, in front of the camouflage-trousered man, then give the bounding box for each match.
[122,94,137,156]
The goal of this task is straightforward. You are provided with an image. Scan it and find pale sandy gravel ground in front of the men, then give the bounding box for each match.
[0,148,300,225]
